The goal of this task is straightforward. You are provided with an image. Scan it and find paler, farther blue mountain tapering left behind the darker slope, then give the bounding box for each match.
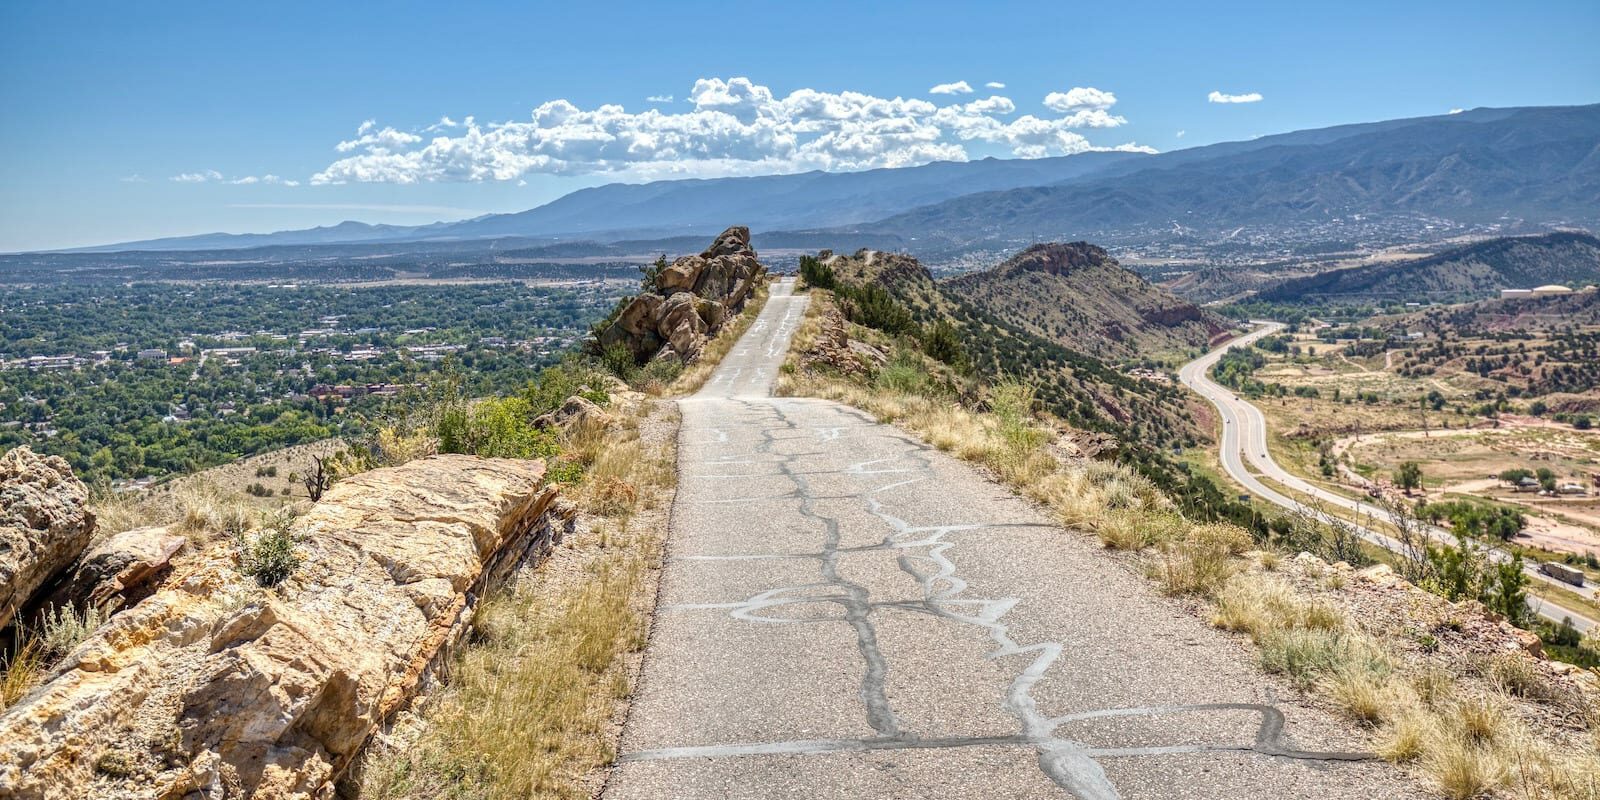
[59,152,1149,253]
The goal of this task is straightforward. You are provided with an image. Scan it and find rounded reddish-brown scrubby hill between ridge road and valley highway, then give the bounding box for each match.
[946,242,1226,358]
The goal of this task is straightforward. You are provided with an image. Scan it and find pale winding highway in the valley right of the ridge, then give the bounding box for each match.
[1178,322,1595,630]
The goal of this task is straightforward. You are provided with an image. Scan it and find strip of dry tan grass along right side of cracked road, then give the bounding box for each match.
[779,291,1600,800]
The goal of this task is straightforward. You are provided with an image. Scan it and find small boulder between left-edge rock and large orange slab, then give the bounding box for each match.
[50,528,189,608]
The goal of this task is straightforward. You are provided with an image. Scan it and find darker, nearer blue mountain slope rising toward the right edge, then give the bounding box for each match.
[845,106,1600,243]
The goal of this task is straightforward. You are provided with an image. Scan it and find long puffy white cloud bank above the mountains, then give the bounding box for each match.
[308,77,1154,184]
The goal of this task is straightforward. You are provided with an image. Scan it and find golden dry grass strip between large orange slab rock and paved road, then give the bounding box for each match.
[360,396,675,800]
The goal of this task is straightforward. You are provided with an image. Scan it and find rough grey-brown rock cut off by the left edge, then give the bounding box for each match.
[0,446,94,627]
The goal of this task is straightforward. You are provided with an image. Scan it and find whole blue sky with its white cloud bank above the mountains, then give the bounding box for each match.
[0,0,1600,251]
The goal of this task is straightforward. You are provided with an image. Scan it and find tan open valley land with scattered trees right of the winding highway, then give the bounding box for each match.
[1234,330,1600,558]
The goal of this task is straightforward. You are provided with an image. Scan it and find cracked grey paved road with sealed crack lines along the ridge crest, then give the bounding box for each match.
[605,285,1418,800]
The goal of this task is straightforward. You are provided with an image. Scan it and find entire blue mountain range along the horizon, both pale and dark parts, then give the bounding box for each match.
[59,104,1600,251]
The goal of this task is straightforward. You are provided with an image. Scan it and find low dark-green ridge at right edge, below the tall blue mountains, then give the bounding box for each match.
[1258,232,1600,302]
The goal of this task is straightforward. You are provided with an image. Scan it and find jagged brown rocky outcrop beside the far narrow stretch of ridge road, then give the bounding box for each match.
[600,226,766,363]
